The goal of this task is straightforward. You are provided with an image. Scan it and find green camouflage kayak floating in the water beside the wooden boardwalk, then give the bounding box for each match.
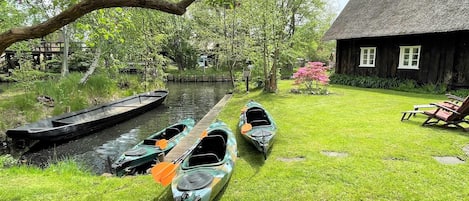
[111,118,195,176]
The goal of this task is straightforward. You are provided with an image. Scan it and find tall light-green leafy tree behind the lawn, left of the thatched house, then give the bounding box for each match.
[187,0,330,92]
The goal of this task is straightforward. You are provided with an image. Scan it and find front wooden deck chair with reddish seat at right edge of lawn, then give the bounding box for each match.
[422,96,469,131]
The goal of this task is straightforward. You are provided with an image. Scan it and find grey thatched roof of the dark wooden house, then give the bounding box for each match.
[323,0,469,40]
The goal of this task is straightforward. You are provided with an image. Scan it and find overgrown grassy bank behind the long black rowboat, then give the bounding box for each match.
[0,72,164,141]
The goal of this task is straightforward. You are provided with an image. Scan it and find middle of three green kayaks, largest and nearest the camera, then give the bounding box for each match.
[171,121,238,201]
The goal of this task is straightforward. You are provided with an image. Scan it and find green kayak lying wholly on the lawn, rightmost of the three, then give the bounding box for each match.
[238,100,277,159]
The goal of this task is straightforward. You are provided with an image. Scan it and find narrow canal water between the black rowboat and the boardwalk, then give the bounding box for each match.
[23,82,231,174]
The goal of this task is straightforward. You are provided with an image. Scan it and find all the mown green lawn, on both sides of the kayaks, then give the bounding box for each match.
[0,81,469,201]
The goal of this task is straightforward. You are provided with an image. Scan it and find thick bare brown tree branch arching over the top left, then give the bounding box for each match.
[0,0,195,54]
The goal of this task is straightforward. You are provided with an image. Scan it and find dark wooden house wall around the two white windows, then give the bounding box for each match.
[336,32,469,87]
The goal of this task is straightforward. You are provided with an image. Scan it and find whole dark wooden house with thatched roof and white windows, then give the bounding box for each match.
[323,0,469,87]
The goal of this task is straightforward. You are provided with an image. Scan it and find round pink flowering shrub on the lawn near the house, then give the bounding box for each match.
[293,62,329,94]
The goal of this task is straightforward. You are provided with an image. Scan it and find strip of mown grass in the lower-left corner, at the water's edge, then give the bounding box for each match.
[0,156,166,200]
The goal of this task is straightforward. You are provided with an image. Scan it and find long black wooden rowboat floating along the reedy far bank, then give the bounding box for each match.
[6,90,168,142]
